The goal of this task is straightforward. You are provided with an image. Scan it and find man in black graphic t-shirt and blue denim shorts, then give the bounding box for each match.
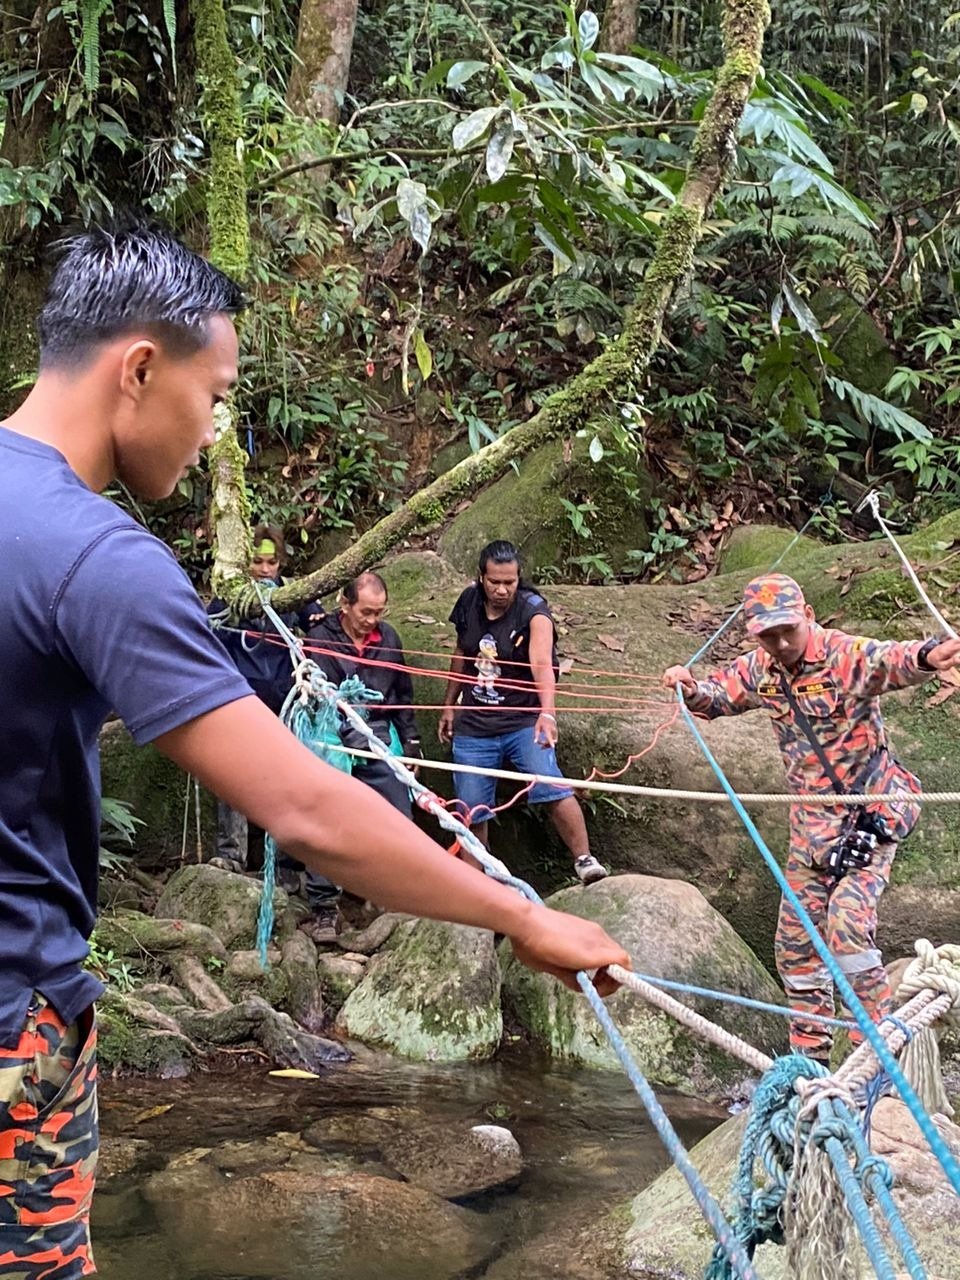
[439,541,607,884]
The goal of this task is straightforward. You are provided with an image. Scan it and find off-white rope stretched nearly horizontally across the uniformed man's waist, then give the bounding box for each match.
[332,746,960,808]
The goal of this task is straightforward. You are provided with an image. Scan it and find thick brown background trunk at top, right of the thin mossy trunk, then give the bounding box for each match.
[287,0,357,125]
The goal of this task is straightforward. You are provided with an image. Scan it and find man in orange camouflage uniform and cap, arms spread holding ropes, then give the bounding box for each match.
[663,573,960,1064]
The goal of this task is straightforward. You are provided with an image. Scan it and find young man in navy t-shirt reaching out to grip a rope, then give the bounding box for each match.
[0,220,628,1280]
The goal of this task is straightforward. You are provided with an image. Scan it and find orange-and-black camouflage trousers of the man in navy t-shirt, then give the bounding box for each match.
[0,995,99,1280]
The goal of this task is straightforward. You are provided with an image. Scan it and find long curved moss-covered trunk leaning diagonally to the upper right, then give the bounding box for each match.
[263,0,769,611]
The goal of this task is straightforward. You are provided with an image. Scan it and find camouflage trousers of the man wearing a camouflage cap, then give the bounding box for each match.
[774,844,896,1060]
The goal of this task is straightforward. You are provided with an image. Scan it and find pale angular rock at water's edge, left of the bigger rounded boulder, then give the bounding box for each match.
[337,920,503,1062]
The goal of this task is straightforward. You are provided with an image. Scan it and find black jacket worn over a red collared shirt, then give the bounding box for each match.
[307,612,420,754]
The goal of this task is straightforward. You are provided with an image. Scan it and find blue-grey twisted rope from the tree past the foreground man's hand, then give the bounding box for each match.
[252,595,759,1280]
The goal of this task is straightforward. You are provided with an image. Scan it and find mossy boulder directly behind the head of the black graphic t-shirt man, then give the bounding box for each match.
[439,436,653,577]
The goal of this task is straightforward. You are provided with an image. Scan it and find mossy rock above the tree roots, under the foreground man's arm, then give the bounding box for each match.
[155,863,287,951]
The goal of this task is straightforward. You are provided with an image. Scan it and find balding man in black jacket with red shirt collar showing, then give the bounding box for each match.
[303,572,422,942]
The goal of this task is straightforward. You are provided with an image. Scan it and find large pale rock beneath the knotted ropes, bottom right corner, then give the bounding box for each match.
[625,1098,960,1280]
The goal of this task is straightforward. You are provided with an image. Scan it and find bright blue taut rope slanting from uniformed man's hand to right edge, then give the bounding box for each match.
[677,687,960,1194]
